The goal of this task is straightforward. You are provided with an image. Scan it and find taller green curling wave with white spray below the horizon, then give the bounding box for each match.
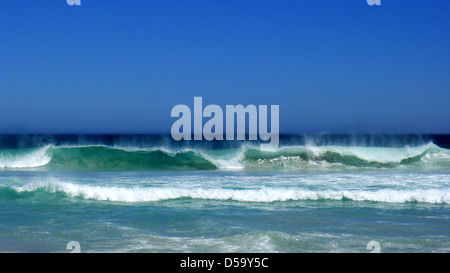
[0,140,450,170]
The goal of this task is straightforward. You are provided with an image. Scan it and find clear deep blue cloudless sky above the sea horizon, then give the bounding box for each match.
[0,0,450,133]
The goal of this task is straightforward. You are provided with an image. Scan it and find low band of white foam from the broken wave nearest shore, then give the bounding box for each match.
[4,181,450,204]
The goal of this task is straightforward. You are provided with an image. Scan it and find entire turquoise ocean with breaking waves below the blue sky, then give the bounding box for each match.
[0,134,450,253]
